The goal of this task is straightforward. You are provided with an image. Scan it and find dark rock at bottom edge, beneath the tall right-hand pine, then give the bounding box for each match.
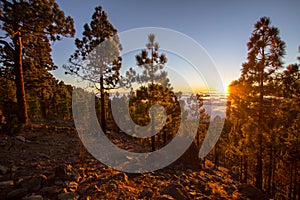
[238,184,269,200]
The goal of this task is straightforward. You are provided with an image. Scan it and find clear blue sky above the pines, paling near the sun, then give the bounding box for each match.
[52,0,300,92]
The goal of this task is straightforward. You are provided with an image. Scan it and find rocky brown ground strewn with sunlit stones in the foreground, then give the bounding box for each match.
[0,122,268,200]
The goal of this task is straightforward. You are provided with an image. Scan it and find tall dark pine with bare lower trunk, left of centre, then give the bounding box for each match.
[63,6,121,132]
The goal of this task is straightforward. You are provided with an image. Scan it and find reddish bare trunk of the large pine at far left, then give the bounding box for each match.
[13,29,28,125]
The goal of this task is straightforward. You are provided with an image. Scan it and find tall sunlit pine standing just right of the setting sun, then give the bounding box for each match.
[226,17,285,189]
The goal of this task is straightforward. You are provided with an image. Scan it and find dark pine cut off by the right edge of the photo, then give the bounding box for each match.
[278,51,300,199]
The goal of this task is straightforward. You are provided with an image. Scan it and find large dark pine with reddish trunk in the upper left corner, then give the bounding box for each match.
[0,0,75,124]
